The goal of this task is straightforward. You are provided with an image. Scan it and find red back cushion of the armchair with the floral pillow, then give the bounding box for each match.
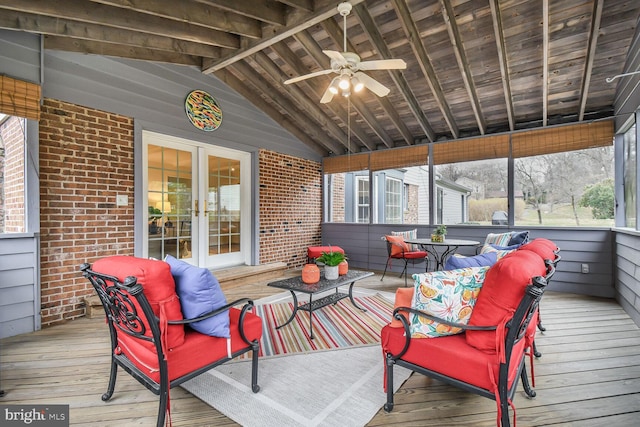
[465,250,546,352]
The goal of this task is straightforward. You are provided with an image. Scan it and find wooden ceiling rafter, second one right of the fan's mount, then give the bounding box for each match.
[392,0,460,138]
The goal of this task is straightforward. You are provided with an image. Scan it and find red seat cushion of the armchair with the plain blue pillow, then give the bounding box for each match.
[116,308,262,382]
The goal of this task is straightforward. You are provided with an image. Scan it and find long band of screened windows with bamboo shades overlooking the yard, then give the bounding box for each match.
[323,120,616,227]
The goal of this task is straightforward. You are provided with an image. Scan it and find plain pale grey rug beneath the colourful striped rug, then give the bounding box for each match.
[182,291,410,427]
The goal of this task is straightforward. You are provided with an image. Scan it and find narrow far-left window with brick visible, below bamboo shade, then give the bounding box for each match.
[0,114,27,233]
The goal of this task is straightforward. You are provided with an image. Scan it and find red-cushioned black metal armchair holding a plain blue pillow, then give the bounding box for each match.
[80,256,262,427]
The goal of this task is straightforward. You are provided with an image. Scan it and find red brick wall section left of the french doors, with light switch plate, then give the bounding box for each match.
[40,99,134,326]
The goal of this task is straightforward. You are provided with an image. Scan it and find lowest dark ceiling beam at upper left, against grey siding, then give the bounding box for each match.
[44,36,202,66]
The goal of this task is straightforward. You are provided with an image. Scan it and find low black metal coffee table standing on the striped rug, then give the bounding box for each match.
[267,270,373,339]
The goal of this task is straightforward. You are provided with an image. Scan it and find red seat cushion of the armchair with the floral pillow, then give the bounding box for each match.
[380,325,525,392]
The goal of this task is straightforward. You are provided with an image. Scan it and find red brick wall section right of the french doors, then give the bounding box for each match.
[259,150,322,268]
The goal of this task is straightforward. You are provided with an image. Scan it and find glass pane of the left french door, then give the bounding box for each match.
[147,145,192,259]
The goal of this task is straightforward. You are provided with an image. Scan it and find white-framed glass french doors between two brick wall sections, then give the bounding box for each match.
[143,132,251,268]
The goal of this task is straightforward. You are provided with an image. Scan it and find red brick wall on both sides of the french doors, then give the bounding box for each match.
[35,99,322,327]
